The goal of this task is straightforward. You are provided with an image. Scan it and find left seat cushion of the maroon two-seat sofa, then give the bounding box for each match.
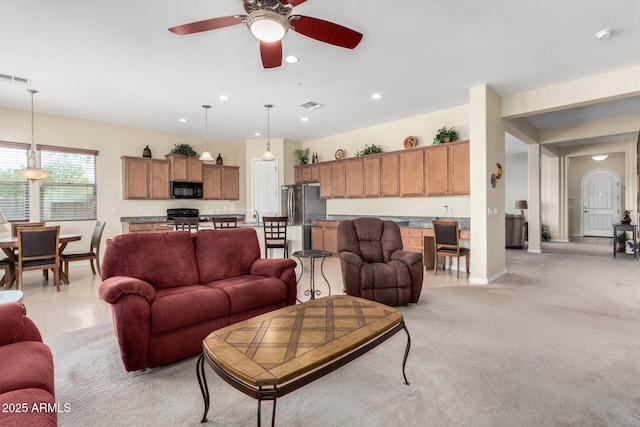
[151,285,230,335]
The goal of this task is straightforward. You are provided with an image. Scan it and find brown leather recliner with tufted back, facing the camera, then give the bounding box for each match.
[338,218,424,306]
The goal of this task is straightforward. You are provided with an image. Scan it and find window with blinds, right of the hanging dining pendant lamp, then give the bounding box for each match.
[38,145,98,221]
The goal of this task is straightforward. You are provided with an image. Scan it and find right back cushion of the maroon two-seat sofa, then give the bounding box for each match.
[195,228,260,283]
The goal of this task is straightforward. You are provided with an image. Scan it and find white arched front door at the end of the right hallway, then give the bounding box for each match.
[582,169,620,237]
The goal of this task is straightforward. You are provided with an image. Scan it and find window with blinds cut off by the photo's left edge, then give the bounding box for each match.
[0,141,29,221]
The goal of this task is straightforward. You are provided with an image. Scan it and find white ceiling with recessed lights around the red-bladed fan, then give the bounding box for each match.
[0,0,640,145]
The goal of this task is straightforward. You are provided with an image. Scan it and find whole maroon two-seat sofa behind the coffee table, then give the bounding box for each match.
[99,228,297,371]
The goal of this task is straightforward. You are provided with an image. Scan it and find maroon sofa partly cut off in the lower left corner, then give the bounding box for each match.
[0,302,58,427]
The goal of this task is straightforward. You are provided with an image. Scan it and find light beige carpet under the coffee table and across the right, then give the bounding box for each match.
[46,244,640,427]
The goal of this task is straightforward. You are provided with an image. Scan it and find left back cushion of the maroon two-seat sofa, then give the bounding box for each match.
[102,231,198,289]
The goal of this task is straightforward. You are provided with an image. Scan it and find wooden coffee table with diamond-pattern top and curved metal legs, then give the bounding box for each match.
[196,295,411,426]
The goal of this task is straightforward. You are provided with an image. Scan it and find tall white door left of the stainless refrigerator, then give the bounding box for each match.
[251,159,280,219]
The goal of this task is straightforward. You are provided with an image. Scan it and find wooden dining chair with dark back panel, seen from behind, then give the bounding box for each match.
[15,225,60,292]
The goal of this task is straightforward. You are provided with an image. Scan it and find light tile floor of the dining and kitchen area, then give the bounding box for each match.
[0,255,469,337]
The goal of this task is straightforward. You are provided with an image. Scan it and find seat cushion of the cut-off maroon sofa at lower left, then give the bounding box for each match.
[0,341,54,394]
